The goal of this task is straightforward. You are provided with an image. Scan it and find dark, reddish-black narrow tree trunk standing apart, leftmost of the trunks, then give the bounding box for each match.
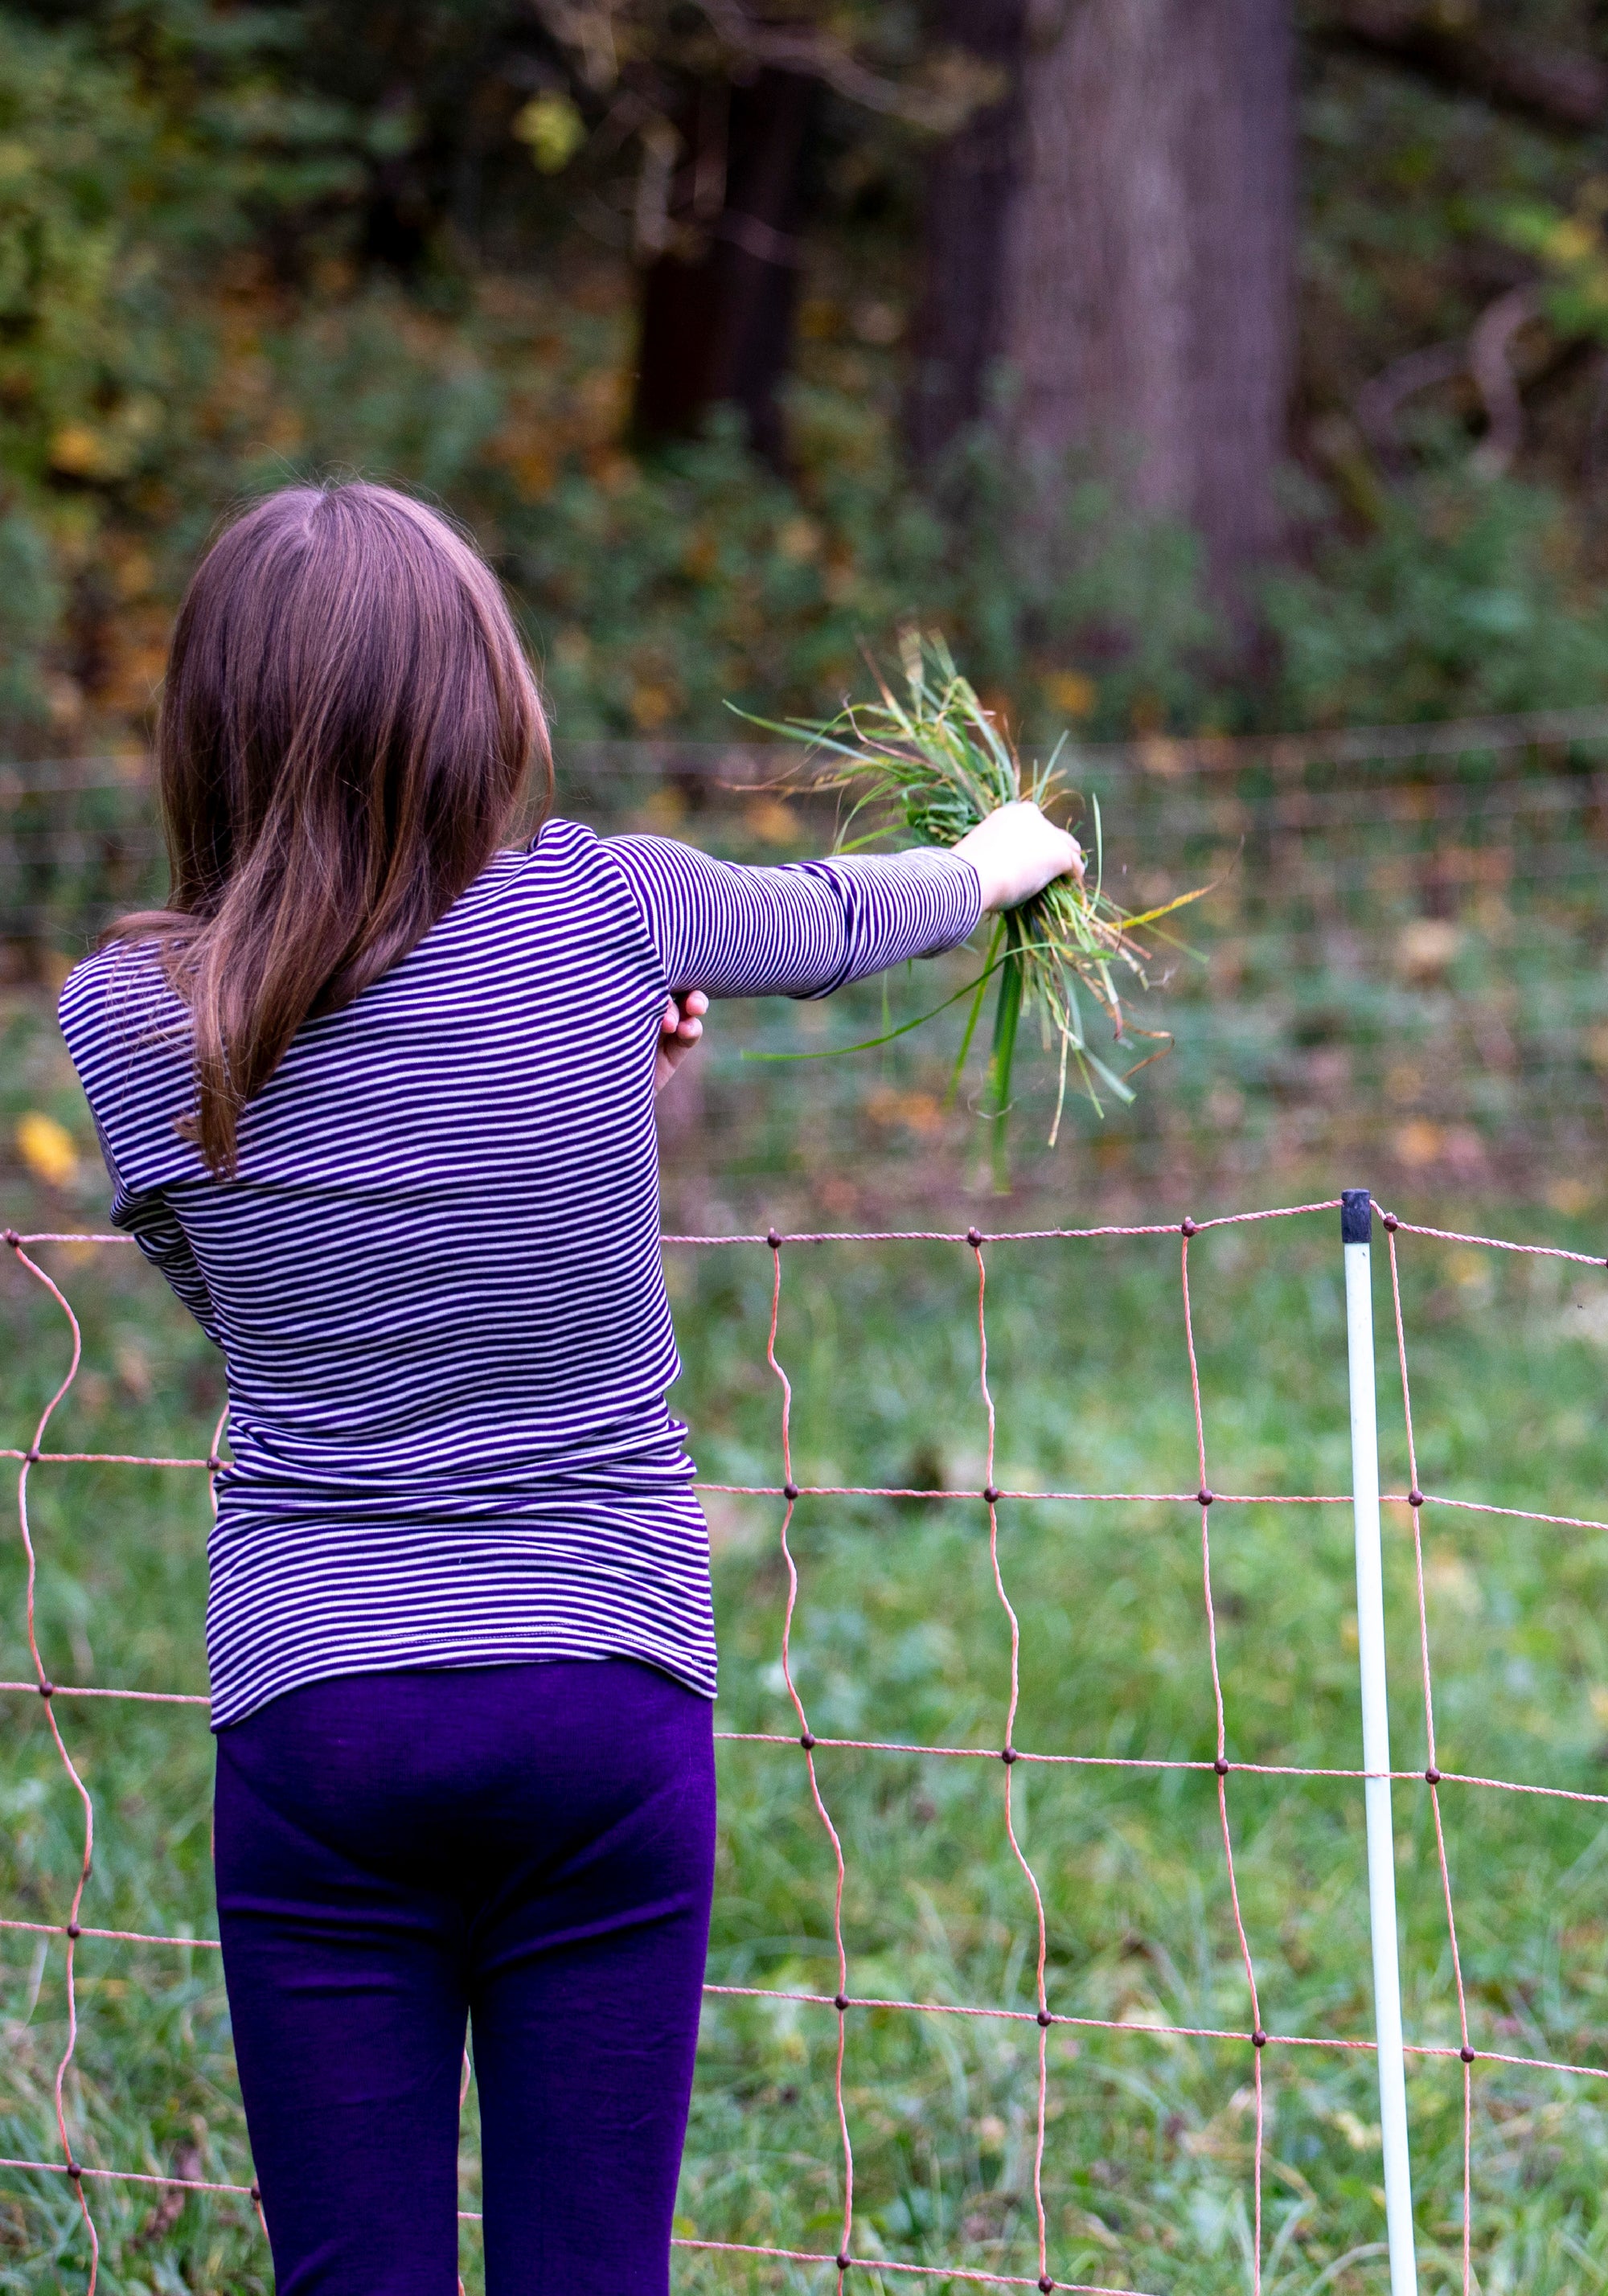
[632,69,818,466]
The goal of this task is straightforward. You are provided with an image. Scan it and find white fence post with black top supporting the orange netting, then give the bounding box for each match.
[1339,1187,1417,2296]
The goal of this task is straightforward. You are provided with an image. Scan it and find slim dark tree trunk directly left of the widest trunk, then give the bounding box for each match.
[905,0,1027,466]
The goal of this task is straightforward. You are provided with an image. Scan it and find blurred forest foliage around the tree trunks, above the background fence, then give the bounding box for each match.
[12,0,1608,748]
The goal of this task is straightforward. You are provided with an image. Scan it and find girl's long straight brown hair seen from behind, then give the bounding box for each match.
[113,482,552,1175]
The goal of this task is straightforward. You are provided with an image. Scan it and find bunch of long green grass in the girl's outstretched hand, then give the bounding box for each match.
[749,629,1204,1178]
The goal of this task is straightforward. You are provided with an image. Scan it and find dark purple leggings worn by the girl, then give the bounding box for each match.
[216,1658,715,2296]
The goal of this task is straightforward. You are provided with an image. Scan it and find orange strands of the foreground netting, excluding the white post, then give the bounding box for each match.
[0,1191,1608,2296]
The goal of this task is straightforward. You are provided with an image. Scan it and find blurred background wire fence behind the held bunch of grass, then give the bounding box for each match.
[0,710,1608,1226]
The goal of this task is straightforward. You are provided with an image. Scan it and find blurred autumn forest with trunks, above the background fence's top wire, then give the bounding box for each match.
[0,0,1608,756]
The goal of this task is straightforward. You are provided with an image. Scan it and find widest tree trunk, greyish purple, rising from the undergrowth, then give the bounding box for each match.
[999,0,1295,604]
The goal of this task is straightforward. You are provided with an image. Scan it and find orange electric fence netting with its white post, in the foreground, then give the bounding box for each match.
[0,1189,1608,2296]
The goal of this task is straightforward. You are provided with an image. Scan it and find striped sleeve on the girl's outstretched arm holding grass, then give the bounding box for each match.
[604,838,983,997]
